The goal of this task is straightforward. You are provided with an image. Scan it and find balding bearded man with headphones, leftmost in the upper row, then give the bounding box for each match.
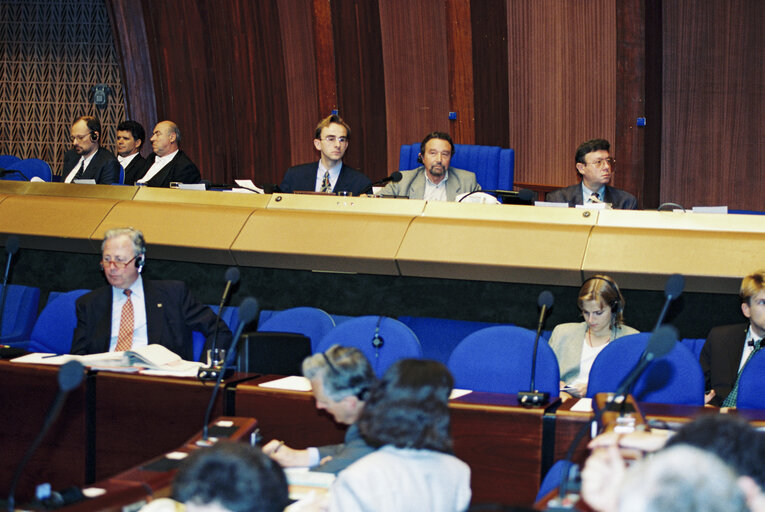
[62,116,120,185]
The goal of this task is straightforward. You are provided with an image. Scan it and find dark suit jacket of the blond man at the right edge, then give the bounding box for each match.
[699,323,749,407]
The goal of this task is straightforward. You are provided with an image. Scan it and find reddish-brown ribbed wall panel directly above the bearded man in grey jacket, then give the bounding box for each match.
[380,0,451,174]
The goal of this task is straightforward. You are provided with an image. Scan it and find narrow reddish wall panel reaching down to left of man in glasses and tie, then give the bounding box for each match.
[275,0,320,166]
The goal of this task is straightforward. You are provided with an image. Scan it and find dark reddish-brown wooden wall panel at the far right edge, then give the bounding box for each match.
[661,0,765,210]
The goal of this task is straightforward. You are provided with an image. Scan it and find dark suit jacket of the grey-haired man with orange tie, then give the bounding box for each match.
[72,279,232,361]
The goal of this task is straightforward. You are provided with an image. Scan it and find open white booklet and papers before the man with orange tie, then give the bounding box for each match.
[12,344,203,377]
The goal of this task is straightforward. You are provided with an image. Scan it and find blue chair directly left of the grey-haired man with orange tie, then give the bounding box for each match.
[28,290,90,354]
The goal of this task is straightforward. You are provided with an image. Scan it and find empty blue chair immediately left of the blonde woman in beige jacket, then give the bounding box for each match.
[448,325,560,397]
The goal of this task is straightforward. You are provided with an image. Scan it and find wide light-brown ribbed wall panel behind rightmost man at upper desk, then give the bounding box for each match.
[507,0,621,186]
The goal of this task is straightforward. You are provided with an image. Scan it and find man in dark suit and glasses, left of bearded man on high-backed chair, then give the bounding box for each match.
[279,115,372,195]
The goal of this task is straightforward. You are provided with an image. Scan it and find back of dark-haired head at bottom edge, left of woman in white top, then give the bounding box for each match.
[173,441,290,512]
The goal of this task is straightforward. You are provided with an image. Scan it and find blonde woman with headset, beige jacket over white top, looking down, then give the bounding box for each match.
[550,275,638,399]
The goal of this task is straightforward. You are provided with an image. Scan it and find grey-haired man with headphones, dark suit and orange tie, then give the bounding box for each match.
[72,228,232,361]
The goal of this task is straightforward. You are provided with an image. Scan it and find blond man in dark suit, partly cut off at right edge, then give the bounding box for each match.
[699,270,765,407]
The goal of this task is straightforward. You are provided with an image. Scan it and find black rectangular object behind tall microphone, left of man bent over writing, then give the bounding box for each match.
[237,332,311,375]
